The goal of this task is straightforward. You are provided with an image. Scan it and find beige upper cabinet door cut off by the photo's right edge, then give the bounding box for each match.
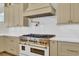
[71,3,79,23]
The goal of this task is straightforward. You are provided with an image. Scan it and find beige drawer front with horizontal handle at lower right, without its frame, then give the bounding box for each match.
[61,42,79,56]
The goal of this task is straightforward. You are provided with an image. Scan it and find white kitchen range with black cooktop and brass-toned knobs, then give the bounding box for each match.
[19,34,55,56]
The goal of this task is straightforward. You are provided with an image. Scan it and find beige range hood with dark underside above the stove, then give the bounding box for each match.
[24,3,56,18]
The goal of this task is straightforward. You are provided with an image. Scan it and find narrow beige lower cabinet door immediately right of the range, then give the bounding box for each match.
[50,40,57,56]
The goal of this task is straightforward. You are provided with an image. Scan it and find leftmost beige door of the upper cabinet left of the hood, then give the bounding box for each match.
[4,6,14,27]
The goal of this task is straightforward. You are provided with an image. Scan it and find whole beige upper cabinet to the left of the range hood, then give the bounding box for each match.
[4,3,28,27]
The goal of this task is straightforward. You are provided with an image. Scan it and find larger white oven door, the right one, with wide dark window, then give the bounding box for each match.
[30,45,49,56]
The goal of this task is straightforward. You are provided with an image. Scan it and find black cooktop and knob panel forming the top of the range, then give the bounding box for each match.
[20,34,52,46]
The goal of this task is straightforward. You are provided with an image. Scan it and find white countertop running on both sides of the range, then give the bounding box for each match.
[0,34,79,42]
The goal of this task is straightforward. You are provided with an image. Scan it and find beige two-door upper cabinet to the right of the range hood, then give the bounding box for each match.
[56,3,79,24]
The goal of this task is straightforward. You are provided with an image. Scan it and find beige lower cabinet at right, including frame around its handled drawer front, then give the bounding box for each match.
[58,42,79,56]
